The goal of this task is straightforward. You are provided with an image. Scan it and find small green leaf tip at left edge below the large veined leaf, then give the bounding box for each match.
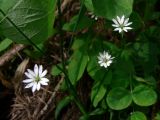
[0,38,12,52]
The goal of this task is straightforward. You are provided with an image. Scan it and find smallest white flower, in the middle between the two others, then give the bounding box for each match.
[98,51,114,68]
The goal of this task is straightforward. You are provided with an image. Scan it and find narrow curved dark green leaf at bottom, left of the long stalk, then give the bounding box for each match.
[55,96,72,120]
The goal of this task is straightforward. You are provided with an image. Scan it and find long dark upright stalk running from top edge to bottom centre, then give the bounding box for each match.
[57,0,87,116]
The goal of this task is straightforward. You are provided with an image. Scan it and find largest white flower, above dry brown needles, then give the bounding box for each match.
[23,64,49,93]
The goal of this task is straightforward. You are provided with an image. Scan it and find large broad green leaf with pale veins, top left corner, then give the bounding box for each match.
[0,0,57,44]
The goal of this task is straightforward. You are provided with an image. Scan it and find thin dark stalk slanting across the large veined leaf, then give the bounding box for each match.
[0,9,44,53]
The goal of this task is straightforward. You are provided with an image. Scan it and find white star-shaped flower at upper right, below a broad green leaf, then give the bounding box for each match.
[112,15,132,33]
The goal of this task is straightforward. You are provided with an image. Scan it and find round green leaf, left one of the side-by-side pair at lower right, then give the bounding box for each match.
[106,87,132,110]
